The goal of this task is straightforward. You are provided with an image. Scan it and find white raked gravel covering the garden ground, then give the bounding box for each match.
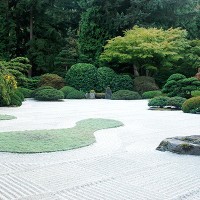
[0,99,200,200]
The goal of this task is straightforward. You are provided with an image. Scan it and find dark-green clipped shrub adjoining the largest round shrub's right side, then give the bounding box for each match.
[96,67,116,92]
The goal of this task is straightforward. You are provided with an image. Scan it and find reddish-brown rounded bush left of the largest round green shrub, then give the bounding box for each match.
[39,74,65,89]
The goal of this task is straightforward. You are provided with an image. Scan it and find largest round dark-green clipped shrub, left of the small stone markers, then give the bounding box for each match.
[65,63,97,92]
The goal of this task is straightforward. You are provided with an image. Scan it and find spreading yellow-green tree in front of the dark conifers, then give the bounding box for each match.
[100,26,190,76]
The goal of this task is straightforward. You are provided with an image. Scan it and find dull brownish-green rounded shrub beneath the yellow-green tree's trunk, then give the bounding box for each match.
[134,76,159,94]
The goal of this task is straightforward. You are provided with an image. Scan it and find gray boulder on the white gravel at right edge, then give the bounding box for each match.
[156,135,200,155]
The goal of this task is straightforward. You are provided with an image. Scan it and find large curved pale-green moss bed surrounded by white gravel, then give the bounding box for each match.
[0,119,123,153]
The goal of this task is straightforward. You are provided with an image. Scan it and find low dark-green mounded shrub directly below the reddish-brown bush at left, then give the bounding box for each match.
[35,89,64,101]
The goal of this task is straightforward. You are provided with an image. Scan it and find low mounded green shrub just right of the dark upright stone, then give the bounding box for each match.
[112,90,141,100]
